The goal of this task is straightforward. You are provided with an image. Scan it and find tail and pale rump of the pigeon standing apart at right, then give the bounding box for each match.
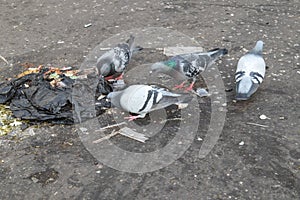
[236,76,258,100]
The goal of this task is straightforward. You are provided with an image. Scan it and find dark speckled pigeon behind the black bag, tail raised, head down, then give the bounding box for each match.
[96,35,142,80]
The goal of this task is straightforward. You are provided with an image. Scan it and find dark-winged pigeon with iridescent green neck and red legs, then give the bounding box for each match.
[151,48,228,91]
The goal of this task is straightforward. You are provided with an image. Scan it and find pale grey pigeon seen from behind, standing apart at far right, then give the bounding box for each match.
[235,40,266,100]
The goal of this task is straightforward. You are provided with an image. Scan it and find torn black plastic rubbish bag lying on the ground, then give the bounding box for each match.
[0,69,112,124]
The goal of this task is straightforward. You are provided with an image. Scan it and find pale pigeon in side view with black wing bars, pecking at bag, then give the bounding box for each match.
[107,85,192,121]
